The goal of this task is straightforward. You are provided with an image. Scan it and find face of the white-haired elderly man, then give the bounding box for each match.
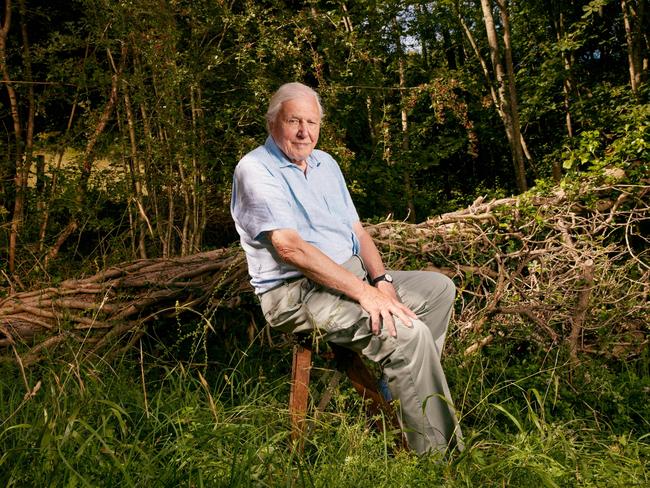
[271,95,320,166]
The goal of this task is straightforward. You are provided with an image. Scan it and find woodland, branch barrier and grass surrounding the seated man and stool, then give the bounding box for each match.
[0,0,650,486]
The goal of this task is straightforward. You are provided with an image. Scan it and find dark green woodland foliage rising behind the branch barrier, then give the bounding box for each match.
[0,0,647,276]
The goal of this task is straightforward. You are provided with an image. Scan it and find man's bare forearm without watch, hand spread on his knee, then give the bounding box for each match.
[268,229,416,336]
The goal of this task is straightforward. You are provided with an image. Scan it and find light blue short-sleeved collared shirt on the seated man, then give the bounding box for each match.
[230,136,360,294]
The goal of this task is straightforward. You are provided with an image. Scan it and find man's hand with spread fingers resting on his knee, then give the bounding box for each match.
[359,283,417,337]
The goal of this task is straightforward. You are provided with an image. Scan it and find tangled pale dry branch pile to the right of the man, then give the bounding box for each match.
[374,181,650,364]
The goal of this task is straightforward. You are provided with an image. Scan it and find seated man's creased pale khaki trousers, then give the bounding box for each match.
[260,256,463,454]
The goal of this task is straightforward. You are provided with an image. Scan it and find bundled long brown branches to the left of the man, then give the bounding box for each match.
[0,248,249,364]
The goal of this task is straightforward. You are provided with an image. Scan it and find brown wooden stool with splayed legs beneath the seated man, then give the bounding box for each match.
[289,341,407,449]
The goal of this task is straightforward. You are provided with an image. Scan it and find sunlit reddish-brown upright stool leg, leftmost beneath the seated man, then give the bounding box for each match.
[289,344,311,447]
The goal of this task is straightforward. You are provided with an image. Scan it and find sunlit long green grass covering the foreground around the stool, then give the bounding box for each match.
[0,328,650,488]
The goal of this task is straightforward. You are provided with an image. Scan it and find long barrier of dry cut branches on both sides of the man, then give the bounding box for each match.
[0,181,650,364]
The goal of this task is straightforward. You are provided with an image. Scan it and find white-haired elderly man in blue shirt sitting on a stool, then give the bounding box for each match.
[231,83,462,453]
